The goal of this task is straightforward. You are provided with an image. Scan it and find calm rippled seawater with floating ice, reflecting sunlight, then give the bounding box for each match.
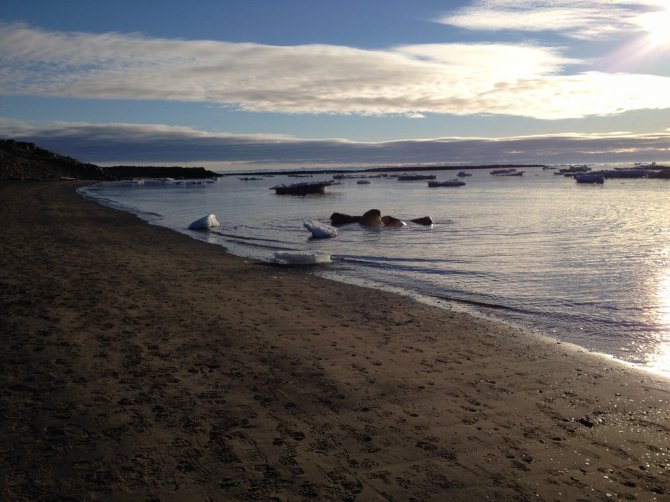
[86,168,670,373]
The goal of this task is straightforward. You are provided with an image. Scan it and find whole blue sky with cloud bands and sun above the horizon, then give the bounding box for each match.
[0,0,670,170]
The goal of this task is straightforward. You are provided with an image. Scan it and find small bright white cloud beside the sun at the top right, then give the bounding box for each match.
[437,0,663,40]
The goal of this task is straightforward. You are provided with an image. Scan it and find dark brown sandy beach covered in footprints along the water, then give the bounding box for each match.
[0,182,670,501]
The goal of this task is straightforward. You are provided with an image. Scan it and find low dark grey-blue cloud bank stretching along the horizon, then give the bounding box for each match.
[0,119,670,169]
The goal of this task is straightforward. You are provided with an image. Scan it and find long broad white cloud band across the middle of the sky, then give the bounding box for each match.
[0,24,670,119]
